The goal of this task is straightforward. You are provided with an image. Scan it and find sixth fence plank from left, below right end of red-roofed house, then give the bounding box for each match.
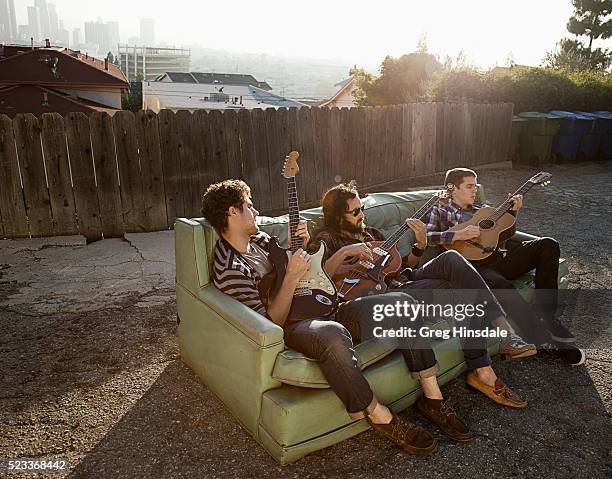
[112,111,146,233]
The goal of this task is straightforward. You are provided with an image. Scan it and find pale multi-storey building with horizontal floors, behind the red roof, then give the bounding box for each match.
[118,45,191,81]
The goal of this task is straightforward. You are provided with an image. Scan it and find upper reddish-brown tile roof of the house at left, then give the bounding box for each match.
[0,46,128,89]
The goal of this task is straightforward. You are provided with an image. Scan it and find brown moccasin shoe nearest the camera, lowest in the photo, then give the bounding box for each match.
[368,412,438,456]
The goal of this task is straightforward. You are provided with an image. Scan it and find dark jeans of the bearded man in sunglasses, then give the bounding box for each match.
[394,251,505,371]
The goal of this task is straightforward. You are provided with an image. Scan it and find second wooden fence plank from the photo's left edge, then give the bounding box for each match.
[13,113,53,237]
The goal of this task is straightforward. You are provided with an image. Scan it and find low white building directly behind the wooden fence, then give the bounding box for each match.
[142,81,304,112]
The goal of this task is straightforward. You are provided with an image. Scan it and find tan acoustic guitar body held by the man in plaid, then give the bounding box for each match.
[443,206,516,264]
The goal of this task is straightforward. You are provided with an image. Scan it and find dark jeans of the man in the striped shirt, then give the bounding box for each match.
[284,292,435,418]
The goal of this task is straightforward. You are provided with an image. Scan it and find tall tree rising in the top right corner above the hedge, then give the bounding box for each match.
[543,0,612,72]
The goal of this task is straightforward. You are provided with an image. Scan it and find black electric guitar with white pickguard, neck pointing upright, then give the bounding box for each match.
[262,151,337,320]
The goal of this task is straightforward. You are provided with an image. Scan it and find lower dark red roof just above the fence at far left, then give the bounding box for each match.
[0,85,119,118]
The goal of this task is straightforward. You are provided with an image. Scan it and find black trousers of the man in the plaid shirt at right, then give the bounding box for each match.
[478,238,560,345]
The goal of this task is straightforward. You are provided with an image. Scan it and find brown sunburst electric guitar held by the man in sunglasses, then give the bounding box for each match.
[336,194,440,301]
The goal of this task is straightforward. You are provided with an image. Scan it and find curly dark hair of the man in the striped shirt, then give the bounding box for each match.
[201,180,251,234]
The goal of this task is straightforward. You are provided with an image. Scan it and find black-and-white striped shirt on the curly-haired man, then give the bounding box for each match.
[213,231,270,317]
